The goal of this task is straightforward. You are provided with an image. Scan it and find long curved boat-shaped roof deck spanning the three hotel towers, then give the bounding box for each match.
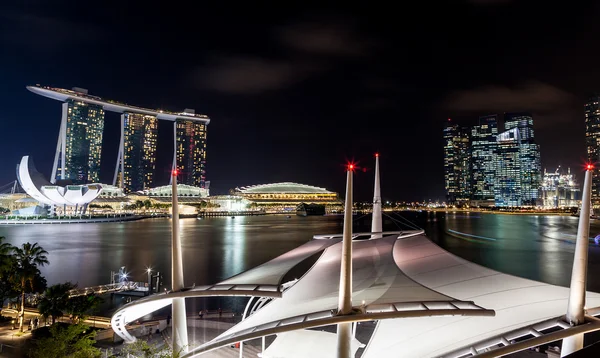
[27,85,210,124]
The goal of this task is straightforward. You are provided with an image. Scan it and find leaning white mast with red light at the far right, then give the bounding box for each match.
[560,164,594,357]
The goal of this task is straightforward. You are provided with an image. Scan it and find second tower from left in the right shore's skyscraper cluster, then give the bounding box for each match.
[471,114,498,204]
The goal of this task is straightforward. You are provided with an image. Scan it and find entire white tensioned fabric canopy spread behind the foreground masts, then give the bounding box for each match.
[198,235,600,358]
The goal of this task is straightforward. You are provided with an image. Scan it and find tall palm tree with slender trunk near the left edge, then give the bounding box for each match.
[13,242,50,332]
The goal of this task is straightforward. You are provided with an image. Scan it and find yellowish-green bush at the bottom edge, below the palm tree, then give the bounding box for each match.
[29,324,101,358]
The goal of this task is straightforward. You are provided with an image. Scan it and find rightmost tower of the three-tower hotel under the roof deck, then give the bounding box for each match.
[175,118,207,188]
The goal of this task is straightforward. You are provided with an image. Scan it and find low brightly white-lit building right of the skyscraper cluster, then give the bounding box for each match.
[540,167,581,209]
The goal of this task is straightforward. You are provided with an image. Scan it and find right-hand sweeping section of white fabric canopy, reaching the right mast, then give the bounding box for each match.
[363,236,600,358]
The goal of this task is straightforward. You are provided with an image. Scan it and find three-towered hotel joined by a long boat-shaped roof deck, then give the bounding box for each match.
[27,85,210,192]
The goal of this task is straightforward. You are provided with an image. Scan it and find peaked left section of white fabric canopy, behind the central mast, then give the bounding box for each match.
[212,235,455,343]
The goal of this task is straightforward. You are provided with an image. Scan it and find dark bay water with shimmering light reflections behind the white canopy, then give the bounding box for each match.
[0,212,600,311]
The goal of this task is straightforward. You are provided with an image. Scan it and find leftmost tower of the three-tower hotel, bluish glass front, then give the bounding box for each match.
[54,99,104,184]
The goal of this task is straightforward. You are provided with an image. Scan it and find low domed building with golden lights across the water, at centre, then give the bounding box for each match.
[231,182,341,211]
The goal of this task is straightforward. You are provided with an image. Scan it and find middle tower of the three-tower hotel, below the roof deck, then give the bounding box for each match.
[123,113,158,192]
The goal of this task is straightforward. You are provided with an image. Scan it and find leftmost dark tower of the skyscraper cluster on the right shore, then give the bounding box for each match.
[444,120,471,205]
